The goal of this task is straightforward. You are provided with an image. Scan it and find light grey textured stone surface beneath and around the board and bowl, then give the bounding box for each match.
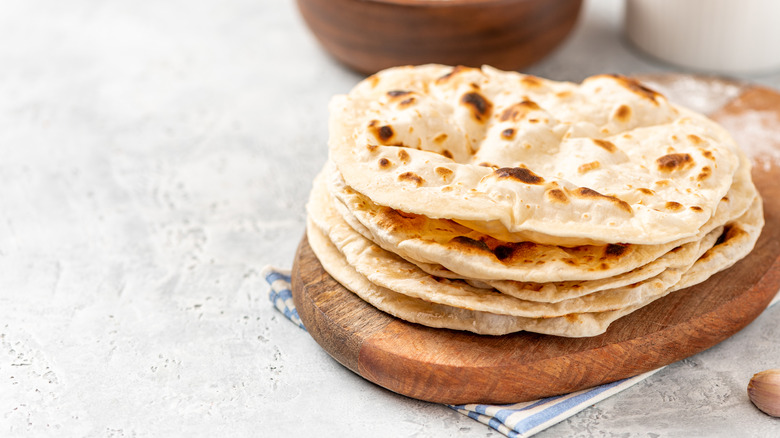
[0,0,780,437]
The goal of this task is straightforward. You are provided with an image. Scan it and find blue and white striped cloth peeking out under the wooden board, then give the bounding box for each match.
[263,266,780,438]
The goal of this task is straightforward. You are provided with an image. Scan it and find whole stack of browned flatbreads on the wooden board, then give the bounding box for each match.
[307,65,764,337]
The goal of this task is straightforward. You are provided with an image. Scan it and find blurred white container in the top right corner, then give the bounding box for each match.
[625,0,780,74]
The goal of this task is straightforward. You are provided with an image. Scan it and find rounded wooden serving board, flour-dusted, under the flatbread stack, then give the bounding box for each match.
[292,75,780,404]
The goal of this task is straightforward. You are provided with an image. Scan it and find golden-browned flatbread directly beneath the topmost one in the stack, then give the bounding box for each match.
[325,153,757,283]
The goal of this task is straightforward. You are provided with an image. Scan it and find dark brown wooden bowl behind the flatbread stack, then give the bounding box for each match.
[297,0,582,74]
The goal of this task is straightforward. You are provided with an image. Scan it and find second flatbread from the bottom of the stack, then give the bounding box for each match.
[307,171,722,318]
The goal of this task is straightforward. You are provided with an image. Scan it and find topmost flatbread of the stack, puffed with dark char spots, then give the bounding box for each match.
[329,65,739,245]
